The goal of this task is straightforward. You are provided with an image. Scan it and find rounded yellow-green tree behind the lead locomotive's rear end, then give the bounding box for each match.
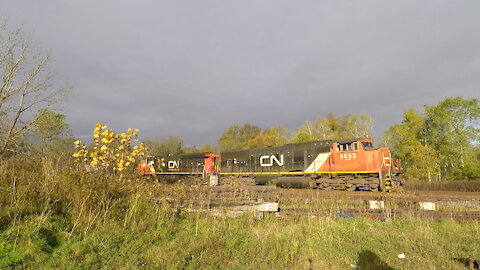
[218,124,262,150]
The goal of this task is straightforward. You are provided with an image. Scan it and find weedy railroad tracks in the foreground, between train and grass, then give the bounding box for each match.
[152,185,480,221]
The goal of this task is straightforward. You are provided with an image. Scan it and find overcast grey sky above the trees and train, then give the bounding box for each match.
[0,0,480,146]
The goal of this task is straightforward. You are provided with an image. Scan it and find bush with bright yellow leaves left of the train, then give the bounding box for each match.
[73,123,146,172]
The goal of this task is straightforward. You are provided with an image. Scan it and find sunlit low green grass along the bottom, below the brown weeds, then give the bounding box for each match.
[0,214,480,269]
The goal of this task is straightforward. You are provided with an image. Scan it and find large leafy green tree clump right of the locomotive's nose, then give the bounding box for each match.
[383,97,480,180]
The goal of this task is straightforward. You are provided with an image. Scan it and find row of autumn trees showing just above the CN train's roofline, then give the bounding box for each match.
[145,113,374,156]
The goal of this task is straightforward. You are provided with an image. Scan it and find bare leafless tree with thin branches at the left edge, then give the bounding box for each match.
[0,22,67,157]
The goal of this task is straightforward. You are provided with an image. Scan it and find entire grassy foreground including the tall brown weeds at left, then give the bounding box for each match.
[0,157,480,269]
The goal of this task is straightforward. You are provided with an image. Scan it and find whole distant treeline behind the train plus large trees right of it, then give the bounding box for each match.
[145,97,480,181]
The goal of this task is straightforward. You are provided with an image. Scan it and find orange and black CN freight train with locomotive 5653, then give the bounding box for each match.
[139,138,402,191]
